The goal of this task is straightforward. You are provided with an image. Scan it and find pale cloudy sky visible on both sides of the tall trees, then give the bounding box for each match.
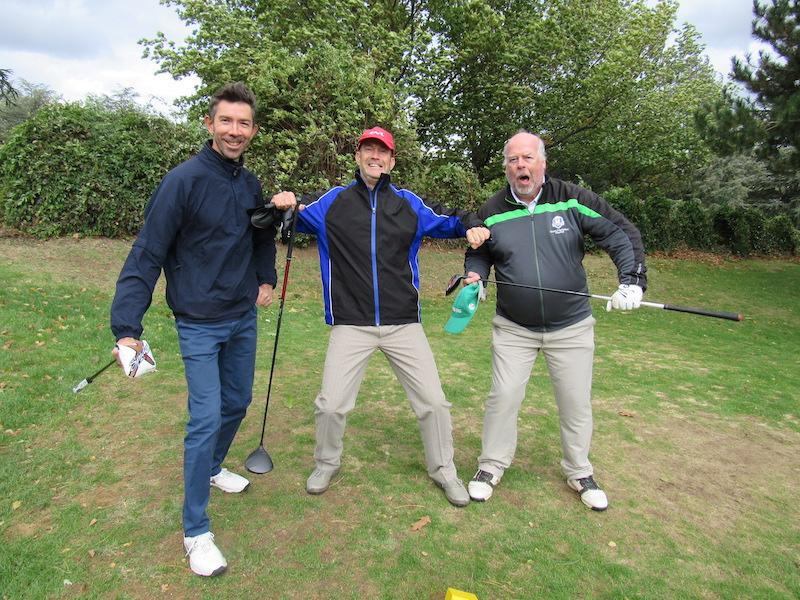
[0,0,758,112]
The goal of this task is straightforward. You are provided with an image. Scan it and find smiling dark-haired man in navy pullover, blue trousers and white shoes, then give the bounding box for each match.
[111,83,293,576]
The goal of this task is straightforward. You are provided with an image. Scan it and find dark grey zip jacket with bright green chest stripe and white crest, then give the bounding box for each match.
[464,177,647,331]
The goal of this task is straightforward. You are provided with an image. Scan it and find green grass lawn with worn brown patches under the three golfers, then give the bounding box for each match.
[0,237,800,600]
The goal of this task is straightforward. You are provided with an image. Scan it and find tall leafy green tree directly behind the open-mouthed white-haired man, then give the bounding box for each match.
[413,0,720,195]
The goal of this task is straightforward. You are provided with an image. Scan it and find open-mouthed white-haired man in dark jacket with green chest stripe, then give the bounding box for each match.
[465,131,647,510]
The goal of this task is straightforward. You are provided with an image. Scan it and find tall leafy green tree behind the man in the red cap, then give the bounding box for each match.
[141,0,422,190]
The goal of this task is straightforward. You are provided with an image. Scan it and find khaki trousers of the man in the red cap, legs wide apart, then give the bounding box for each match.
[314,323,457,483]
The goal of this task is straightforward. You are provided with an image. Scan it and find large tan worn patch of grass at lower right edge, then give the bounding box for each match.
[612,414,800,539]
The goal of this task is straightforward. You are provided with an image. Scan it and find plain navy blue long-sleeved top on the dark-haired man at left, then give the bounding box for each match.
[111,140,277,339]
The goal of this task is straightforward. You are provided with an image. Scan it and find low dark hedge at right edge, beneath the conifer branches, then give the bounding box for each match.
[603,187,800,256]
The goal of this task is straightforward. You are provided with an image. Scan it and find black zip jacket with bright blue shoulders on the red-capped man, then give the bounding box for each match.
[297,172,481,326]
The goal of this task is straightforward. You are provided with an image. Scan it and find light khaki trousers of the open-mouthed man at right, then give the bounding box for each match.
[478,315,595,479]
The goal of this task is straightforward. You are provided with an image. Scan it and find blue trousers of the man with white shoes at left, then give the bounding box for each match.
[175,306,256,537]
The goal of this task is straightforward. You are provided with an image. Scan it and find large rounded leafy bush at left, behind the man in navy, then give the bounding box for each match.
[0,103,205,237]
